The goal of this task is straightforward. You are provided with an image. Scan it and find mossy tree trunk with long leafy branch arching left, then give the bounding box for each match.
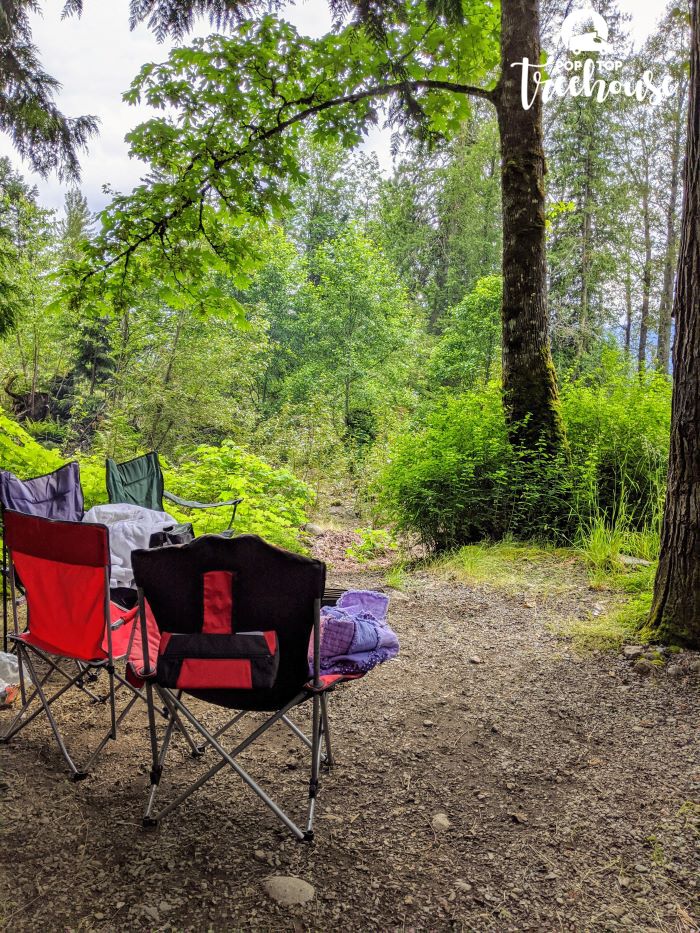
[494,0,565,453]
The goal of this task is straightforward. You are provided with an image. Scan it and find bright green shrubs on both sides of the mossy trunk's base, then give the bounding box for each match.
[377,353,671,550]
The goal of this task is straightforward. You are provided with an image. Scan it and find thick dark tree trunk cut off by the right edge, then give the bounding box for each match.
[649,0,700,648]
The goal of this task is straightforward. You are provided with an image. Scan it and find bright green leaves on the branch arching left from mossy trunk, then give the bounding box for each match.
[75,0,499,296]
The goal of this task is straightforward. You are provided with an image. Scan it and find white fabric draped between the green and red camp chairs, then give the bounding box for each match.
[83,502,176,588]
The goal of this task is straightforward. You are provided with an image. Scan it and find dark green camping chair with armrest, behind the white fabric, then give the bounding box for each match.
[107,451,243,535]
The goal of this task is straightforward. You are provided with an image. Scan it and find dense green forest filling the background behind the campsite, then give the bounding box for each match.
[0,0,689,640]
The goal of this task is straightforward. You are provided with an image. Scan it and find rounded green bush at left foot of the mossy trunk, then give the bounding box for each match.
[379,384,568,550]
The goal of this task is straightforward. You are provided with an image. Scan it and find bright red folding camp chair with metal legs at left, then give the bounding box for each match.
[0,510,145,780]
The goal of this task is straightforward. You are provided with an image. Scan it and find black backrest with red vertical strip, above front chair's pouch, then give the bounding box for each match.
[131,535,326,694]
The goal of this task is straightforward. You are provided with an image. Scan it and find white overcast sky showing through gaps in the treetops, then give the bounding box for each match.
[0,0,665,217]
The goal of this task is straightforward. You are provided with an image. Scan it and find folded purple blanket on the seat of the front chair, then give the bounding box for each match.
[309,590,399,674]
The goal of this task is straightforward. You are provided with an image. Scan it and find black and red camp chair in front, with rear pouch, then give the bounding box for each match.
[132,535,364,840]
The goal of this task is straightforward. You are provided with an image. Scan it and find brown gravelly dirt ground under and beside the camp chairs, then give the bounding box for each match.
[0,544,700,933]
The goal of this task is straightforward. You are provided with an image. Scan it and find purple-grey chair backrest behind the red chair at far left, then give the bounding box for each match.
[0,461,85,522]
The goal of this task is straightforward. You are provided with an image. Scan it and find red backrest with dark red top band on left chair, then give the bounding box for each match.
[4,510,109,661]
